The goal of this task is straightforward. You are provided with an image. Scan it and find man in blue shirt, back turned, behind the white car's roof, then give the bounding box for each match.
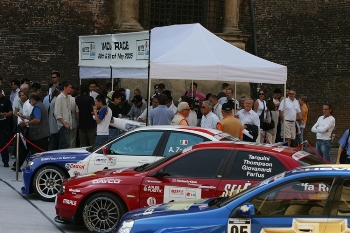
[150,94,174,125]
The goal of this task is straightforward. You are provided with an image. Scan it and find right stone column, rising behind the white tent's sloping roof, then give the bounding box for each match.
[223,0,242,33]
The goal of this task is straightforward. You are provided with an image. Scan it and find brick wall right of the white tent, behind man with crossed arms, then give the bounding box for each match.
[239,0,350,146]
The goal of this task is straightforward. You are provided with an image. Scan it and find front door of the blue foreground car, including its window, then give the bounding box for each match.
[228,177,334,233]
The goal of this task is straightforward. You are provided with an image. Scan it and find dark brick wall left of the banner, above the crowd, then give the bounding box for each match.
[0,0,115,93]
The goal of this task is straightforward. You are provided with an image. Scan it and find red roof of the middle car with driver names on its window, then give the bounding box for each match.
[192,141,298,155]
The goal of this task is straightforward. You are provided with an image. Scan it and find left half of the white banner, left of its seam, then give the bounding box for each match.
[79,34,112,67]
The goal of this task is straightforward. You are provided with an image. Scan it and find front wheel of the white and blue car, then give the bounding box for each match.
[33,166,68,202]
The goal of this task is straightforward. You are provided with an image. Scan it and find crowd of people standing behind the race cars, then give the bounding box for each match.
[0,72,346,170]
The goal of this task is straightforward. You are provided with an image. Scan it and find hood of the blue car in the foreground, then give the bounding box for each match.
[123,198,217,219]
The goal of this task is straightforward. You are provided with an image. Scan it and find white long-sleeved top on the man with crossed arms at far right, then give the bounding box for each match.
[311,116,335,140]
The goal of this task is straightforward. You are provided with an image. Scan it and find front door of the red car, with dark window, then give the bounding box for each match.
[140,149,229,207]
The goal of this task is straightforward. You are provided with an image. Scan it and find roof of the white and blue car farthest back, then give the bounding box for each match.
[134,125,227,136]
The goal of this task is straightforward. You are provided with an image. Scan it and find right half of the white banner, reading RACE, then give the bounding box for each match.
[111,31,149,68]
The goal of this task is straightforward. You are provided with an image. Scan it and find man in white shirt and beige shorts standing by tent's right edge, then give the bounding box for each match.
[278,89,302,146]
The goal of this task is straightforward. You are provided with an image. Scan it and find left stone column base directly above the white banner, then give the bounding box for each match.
[115,0,144,32]
